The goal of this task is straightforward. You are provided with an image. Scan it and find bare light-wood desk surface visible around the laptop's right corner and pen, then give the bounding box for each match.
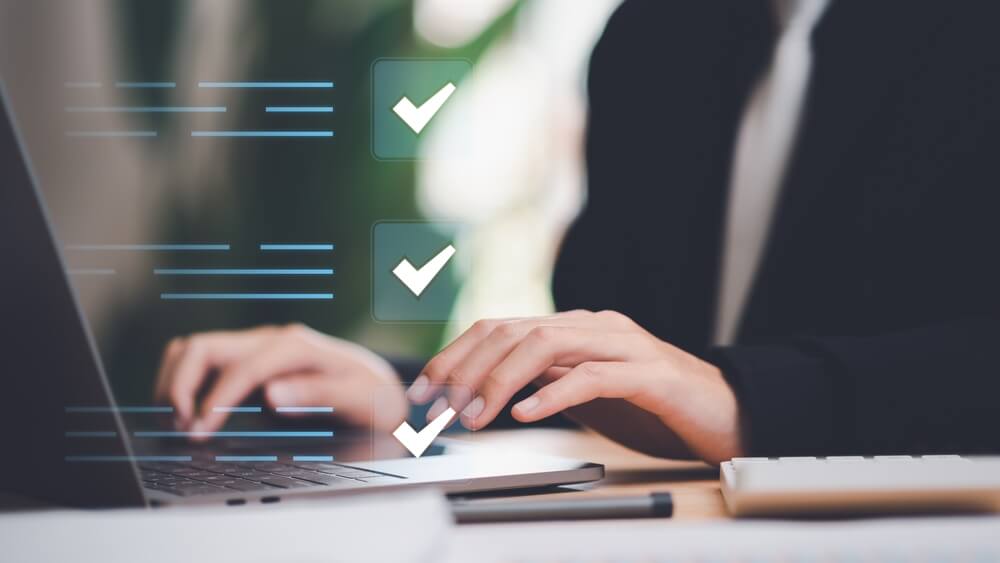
[458,429,729,521]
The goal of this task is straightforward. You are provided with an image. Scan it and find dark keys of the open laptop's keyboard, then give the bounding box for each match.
[139,462,403,497]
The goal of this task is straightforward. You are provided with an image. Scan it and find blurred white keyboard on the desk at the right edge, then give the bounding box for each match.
[722,455,1000,516]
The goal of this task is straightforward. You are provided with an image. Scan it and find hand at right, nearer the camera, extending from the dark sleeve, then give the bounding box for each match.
[407,311,743,462]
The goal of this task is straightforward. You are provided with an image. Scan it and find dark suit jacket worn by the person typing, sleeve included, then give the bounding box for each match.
[554,0,1000,455]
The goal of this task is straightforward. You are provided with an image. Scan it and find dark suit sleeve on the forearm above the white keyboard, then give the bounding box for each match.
[710,318,1000,455]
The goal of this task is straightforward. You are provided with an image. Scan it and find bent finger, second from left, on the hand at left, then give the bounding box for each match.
[164,329,270,426]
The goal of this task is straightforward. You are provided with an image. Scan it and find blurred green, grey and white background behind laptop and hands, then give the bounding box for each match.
[0,0,619,403]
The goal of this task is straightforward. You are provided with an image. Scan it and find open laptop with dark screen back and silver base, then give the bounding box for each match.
[0,83,604,507]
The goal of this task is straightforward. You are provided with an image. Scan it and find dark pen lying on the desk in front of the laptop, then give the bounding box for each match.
[451,492,674,524]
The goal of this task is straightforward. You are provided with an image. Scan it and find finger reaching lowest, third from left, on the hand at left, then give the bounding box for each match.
[192,335,315,432]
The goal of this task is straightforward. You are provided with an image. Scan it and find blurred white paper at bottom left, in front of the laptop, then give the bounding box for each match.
[0,491,451,563]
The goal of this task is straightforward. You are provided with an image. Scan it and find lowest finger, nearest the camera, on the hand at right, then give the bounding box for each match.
[511,362,655,422]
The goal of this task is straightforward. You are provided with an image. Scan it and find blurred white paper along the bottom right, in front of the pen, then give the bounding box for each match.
[444,516,1000,563]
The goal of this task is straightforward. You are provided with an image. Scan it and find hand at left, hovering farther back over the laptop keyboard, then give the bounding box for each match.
[156,324,408,440]
